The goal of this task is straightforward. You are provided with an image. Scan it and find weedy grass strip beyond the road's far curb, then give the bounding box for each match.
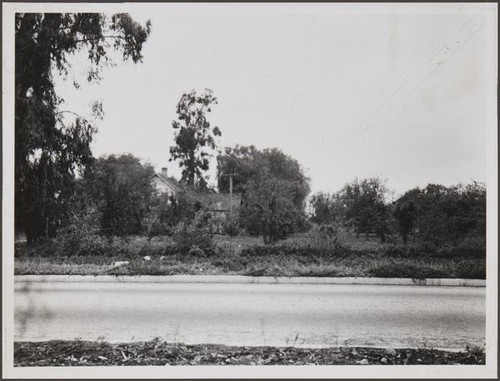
[15,235,486,279]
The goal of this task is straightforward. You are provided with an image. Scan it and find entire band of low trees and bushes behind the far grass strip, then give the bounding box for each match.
[16,146,486,247]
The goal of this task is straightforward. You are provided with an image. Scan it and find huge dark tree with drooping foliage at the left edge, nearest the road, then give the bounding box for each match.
[15,13,150,242]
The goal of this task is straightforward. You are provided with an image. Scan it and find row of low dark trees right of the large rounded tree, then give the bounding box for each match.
[311,178,486,245]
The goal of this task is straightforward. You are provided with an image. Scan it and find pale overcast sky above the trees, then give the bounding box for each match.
[52,4,496,194]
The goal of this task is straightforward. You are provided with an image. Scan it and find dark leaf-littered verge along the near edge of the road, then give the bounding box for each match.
[14,340,485,367]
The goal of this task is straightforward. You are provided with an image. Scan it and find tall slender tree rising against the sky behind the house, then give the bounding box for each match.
[170,89,221,190]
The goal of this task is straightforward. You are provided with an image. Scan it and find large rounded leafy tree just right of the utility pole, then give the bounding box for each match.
[217,146,309,243]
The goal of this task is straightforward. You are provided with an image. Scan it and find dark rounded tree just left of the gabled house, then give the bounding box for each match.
[84,155,154,237]
